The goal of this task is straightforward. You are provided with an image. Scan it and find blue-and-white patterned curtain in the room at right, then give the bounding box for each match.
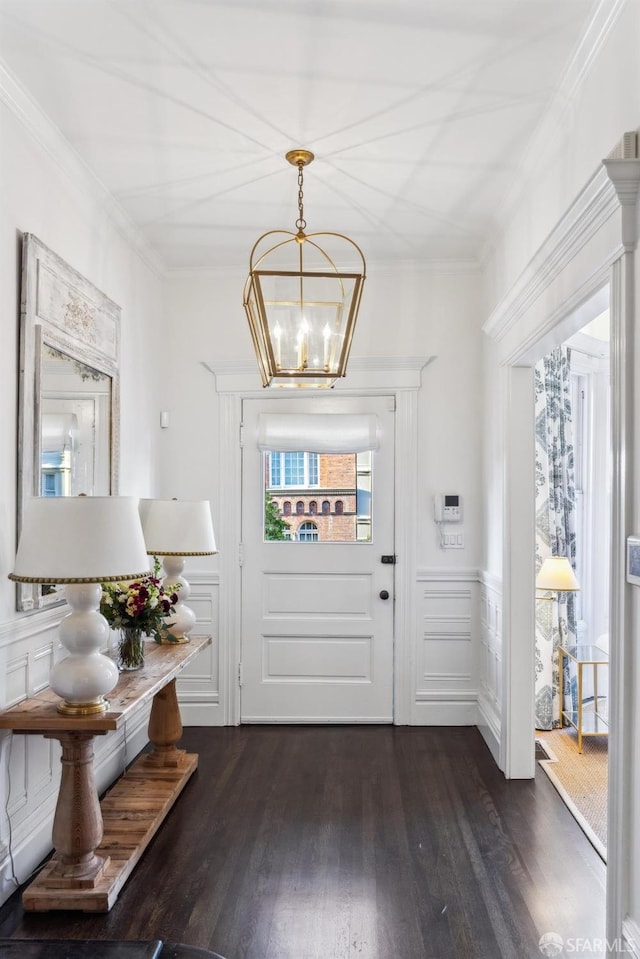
[535,346,577,729]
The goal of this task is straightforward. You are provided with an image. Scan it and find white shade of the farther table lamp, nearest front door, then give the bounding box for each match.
[139,499,218,556]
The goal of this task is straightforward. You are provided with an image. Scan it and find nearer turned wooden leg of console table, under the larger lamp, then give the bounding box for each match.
[47,732,109,887]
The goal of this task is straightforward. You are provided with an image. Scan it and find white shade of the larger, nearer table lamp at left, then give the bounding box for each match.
[9,496,151,583]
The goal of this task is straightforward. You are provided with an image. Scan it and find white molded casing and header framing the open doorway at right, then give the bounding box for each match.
[484,150,640,952]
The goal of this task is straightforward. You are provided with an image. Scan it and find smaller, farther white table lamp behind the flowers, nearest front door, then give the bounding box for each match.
[139,499,218,643]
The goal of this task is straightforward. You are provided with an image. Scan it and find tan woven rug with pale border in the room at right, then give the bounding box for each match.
[536,729,608,862]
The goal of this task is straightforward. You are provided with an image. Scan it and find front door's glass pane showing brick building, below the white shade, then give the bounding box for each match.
[263,451,372,543]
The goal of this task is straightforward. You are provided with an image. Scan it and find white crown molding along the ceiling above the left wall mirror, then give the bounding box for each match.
[0,60,166,276]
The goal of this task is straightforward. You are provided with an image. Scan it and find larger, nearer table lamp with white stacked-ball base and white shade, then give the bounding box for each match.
[9,496,151,716]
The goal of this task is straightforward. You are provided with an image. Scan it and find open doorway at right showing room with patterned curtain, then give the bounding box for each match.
[535,296,612,861]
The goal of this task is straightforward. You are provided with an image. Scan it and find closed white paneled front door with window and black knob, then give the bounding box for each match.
[240,395,395,723]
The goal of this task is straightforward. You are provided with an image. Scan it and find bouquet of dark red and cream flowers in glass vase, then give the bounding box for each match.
[100,557,180,670]
